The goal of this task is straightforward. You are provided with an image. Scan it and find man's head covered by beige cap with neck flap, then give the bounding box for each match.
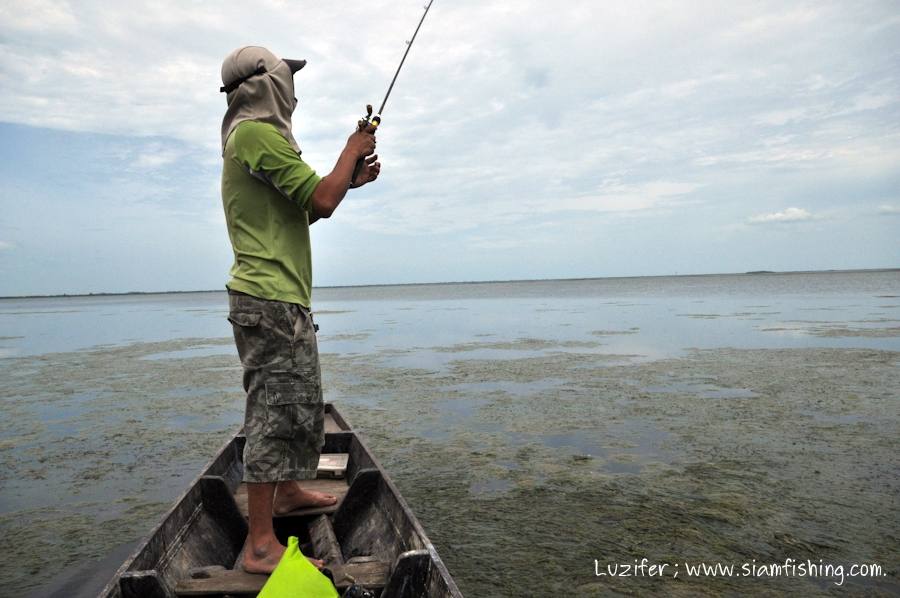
[220,46,306,151]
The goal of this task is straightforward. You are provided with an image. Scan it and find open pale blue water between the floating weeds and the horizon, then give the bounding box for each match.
[0,271,900,359]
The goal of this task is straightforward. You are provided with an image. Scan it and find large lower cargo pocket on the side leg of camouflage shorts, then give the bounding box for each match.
[263,370,322,440]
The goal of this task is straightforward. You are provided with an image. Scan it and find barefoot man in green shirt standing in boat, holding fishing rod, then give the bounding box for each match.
[222,46,381,573]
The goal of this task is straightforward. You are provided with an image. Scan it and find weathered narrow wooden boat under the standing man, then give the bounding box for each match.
[100,403,462,598]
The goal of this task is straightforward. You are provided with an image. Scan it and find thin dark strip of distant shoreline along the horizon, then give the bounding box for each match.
[0,268,900,300]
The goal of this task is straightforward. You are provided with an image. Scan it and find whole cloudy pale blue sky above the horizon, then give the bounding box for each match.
[0,0,900,296]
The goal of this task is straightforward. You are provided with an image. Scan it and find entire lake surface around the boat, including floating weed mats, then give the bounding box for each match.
[0,270,900,596]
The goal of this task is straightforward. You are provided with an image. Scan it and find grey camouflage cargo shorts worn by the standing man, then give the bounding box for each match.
[228,291,325,483]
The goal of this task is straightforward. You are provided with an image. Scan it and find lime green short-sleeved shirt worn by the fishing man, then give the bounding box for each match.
[222,121,320,307]
